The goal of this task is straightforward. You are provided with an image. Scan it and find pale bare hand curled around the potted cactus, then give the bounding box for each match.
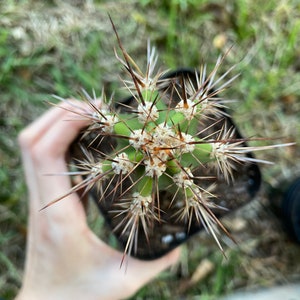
[17,102,180,300]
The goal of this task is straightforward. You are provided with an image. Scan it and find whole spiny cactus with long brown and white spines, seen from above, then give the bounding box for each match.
[46,19,292,258]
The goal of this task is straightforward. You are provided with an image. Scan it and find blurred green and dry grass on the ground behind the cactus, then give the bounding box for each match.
[0,0,300,299]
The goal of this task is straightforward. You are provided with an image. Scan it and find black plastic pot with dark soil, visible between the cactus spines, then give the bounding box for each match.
[69,69,261,260]
